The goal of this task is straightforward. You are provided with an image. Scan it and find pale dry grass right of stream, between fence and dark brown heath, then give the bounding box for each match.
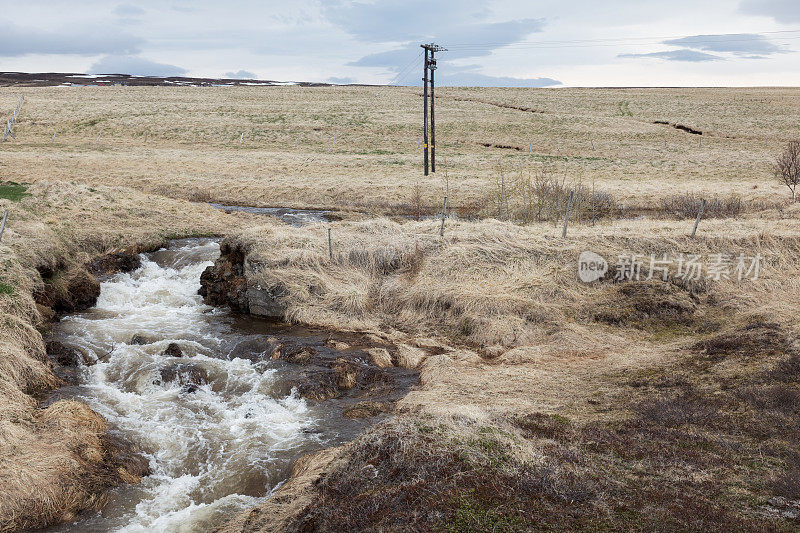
[216,208,800,420]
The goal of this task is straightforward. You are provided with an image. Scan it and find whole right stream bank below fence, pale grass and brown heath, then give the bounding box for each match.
[219,210,800,532]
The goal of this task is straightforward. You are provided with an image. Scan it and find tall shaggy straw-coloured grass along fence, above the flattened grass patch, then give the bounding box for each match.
[230,214,800,348]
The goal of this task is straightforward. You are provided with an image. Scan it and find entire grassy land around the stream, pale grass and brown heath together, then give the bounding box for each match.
[0,87,800,531]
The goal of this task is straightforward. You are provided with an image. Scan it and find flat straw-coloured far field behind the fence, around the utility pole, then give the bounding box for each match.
[0,87,800,214]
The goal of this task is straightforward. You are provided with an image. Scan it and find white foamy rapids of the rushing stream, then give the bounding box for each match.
[48,239,319,532]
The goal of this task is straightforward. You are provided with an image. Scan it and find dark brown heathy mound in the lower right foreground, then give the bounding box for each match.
[268,310,800,531]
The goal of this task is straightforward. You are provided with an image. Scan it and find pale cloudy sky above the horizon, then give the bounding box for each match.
[0,0,800,86]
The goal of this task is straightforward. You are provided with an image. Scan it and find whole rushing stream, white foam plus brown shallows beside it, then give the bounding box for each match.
[45,239,418,532]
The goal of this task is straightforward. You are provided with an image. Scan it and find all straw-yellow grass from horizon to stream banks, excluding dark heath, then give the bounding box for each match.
[0,87,800,527]
